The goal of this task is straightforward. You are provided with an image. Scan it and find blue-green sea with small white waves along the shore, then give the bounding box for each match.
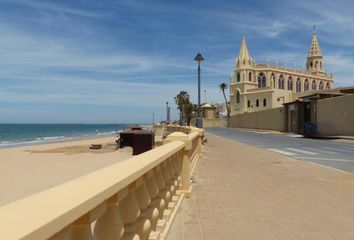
[0,123,139,148]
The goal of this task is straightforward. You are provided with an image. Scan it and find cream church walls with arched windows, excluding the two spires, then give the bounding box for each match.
[230,64,333,115]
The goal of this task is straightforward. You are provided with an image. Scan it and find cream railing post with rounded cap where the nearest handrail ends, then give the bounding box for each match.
[165,132,192,197]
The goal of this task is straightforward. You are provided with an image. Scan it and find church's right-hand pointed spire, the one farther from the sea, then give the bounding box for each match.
[306,28,325,76]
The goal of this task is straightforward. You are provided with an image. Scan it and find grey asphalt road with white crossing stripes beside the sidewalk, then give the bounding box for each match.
[206,128,354,173]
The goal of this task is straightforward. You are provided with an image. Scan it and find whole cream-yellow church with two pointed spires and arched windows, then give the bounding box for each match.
[230,30,333,115]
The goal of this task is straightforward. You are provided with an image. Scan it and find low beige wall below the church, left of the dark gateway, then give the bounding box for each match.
[230,107,285,131]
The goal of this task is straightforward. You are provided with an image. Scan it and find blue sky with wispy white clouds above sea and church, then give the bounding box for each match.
[0,0,354,123]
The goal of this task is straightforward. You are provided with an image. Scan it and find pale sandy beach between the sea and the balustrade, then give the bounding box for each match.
[0,136,132,206]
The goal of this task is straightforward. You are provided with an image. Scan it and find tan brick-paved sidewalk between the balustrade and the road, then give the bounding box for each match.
[167,135,354,240]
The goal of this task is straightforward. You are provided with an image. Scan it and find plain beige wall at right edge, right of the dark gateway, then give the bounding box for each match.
[316,94,354,136]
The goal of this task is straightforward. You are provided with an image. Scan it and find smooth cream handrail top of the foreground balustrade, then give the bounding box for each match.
[0,141,185,240]
